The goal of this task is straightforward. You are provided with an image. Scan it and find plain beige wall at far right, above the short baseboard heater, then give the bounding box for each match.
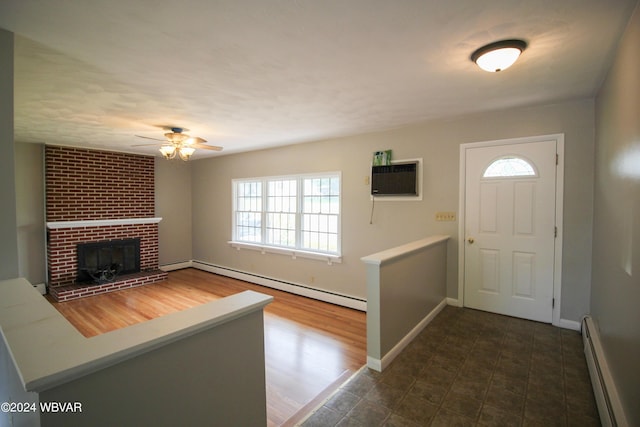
[591,2,640,426]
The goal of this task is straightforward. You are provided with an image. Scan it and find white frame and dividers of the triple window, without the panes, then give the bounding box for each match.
[228,171,342,264]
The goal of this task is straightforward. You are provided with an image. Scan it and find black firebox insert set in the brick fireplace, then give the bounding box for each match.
[76,238,140,283]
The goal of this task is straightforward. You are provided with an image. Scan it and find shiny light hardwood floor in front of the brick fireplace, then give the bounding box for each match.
[47,268,366,426]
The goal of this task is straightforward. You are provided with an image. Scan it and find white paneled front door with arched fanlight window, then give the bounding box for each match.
[463,139,557,323]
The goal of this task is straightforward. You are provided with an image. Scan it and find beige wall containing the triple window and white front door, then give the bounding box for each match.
[191,100,594,321]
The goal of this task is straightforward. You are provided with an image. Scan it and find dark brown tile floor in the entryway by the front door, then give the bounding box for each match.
[302,306,600,427]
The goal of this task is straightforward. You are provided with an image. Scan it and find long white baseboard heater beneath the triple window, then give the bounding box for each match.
[191,260,367,312]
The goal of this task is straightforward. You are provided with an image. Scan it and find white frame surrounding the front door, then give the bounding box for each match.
[458,133,564,326]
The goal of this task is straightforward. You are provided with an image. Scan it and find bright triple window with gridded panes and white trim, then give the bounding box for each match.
[231,172,341,256]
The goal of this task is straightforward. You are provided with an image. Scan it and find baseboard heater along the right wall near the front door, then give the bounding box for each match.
[582,316,628,427]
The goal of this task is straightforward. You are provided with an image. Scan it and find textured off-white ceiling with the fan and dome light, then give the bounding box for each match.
[0,0,636,158]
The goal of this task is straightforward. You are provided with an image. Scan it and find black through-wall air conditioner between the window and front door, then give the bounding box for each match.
[371,160,420,197]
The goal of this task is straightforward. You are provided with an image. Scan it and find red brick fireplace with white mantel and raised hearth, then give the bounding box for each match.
[45,146,167,301]
